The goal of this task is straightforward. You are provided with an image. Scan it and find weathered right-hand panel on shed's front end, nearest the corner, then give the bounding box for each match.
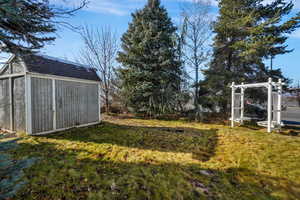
[12,76,26,132]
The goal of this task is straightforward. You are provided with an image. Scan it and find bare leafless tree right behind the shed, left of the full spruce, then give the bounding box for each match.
[79,26,118,113]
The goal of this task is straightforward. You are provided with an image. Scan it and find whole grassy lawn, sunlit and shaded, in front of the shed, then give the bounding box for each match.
[0,118,300,200]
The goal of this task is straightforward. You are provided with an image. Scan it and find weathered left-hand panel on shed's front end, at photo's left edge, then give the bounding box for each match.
[0,78,10,130]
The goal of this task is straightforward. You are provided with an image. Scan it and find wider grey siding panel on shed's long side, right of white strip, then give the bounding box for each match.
[55,80,99,129]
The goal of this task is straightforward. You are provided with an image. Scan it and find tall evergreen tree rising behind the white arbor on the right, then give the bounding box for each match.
[201,0,300,113]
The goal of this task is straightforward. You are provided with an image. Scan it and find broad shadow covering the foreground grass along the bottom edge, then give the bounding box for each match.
[12,141,300,200]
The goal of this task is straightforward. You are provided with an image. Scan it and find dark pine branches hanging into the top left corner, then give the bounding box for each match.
[0,0,87,54]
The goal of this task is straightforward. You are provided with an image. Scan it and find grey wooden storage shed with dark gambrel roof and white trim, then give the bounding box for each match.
[0,55,100,135]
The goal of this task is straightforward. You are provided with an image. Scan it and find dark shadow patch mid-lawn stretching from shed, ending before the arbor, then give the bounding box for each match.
[44,122,218,162]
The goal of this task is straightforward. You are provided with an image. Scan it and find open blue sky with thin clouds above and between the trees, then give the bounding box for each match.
[1,0,300,85]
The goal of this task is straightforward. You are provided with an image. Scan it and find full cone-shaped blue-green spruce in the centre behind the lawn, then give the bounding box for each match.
[117,0,181,116]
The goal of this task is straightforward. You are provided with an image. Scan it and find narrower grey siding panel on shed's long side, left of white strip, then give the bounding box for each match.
[31,77,53,134]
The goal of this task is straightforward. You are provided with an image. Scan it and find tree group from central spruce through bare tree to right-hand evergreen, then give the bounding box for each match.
[117,0,300,120]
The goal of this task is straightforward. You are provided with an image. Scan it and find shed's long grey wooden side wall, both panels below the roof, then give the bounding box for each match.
[31,77,100,134]
